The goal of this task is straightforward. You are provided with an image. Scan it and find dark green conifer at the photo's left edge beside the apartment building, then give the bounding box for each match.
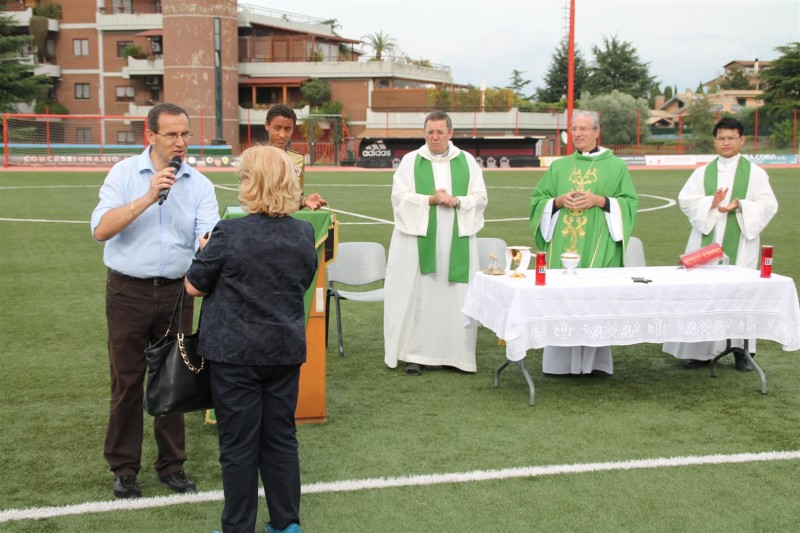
[0,14,51,113]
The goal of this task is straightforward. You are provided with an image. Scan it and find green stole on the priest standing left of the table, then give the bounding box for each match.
[414,152,469,283]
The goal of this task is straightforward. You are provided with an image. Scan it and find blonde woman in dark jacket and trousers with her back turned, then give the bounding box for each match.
[186,146,317,533]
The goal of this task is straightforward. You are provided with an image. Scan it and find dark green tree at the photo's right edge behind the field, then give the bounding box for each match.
[760,42,800,119]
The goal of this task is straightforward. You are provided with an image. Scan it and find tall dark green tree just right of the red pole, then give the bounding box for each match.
[585,35,655,98]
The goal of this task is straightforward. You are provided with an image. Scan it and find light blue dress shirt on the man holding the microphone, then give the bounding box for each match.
[91,147,219,278]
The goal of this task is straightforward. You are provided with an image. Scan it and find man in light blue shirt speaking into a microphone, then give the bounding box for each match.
[91,104,219,498]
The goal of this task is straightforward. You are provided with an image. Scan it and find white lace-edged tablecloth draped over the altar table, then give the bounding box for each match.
[462,265,800,361]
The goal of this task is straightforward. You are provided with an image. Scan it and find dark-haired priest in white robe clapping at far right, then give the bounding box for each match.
[663,117,778,371]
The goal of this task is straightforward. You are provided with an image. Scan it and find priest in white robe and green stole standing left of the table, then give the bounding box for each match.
[383,111,488,375]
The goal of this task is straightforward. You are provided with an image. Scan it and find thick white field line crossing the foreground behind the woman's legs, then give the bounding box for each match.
[0,450,800,523]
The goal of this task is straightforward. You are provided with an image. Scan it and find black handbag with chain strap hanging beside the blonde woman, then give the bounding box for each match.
[144,287,213,416]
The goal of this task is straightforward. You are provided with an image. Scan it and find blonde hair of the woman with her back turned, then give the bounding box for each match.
[239,146,302,216]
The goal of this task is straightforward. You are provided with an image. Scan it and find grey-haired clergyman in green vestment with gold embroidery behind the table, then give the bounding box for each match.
[530,111,639,374]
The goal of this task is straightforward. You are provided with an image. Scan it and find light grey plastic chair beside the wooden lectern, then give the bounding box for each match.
[325,242,386,357]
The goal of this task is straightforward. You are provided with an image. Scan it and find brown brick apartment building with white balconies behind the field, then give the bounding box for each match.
[5,0,566,164]
